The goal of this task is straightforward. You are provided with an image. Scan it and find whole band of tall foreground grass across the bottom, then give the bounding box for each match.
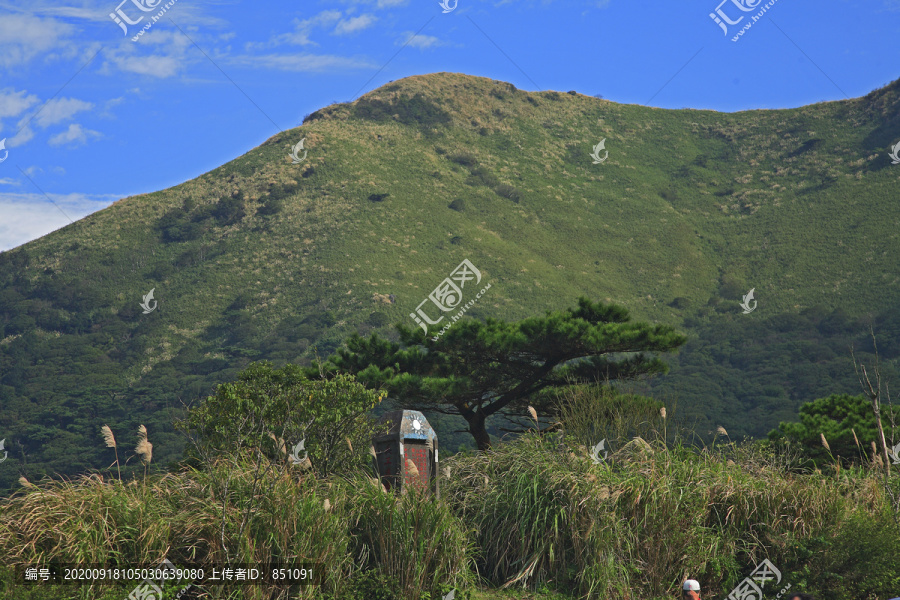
[0,384,900,600]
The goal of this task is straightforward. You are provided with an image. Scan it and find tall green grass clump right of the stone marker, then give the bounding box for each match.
[444,386,885,598]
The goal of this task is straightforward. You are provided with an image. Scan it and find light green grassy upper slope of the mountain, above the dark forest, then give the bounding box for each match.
[0,73,900,488]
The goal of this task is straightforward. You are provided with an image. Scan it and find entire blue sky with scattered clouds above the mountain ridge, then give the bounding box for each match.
[0,0,900,251]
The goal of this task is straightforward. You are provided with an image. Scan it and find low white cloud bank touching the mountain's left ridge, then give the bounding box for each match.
[0,193,119,252]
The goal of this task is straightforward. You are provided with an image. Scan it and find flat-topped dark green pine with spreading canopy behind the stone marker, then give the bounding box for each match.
[320,298,685,450]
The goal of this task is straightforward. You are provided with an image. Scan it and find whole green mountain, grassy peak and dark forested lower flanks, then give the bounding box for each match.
[0,73,900,488]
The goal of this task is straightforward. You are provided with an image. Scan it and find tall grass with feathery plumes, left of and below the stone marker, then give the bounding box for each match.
[0,457,472,600]
